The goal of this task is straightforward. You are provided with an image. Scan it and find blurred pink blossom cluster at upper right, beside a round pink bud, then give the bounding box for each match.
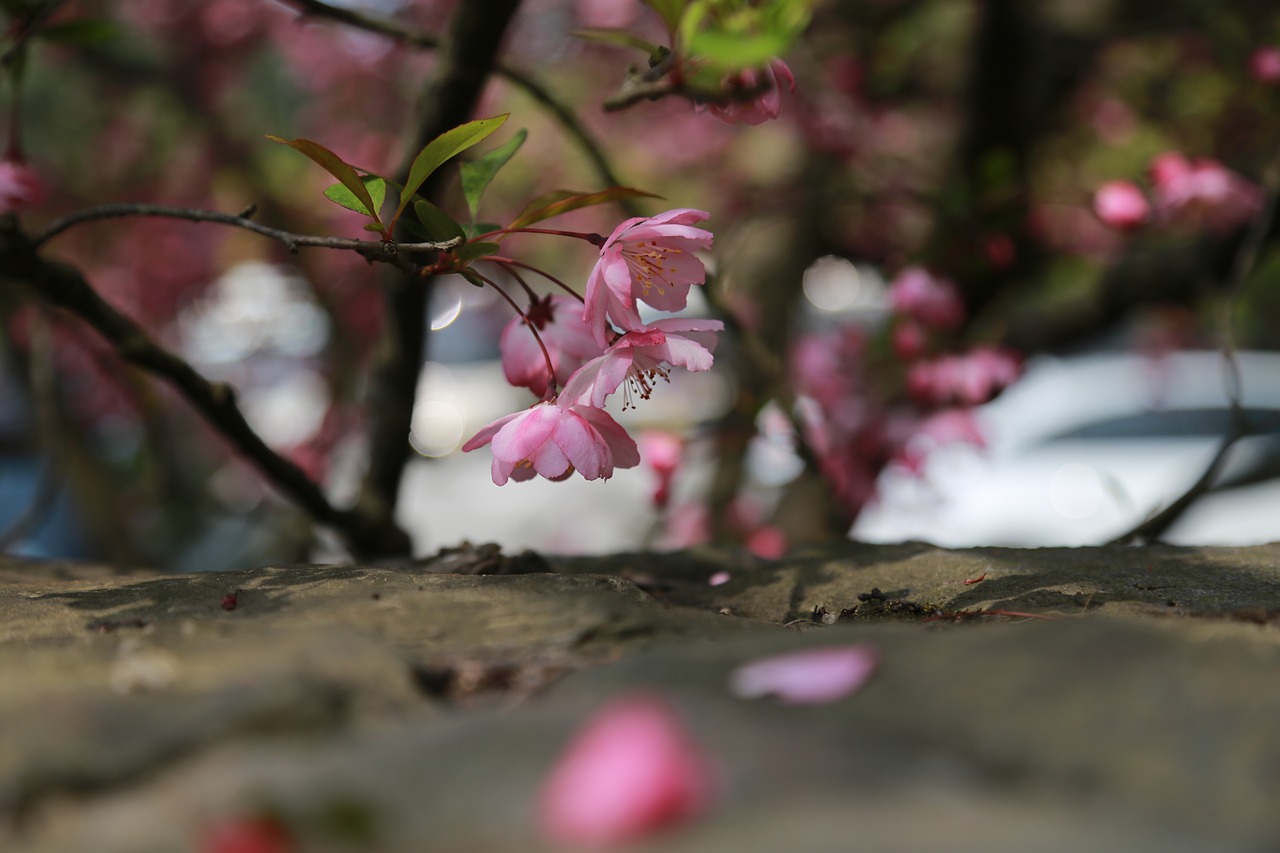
[1151,151,1262,232]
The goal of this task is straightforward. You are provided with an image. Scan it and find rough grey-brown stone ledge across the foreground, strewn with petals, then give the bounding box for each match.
[0,544,1280,853]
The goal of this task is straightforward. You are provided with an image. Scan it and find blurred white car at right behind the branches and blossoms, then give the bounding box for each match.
[851,352,1280,547]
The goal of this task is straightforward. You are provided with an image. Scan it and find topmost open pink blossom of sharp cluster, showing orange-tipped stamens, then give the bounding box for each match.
[582,207,712,347]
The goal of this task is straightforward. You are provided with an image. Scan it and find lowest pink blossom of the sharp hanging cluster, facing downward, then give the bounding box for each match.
[462,402,640,485]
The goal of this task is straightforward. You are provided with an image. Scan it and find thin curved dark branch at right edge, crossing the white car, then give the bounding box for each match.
[1108,159,1280,544]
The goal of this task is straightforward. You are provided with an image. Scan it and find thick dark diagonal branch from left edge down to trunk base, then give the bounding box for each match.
[0,220,410,556]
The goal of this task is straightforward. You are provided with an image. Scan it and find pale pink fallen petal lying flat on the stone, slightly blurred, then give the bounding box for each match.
[730,644,879,704]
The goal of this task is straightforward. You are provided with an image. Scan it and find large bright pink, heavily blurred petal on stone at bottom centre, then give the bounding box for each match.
[538,694,714,848]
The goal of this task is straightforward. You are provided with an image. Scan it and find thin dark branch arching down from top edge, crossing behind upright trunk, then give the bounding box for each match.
[280,0,644,216]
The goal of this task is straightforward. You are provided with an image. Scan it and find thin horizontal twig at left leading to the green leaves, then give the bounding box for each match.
[31,204,462,263]
